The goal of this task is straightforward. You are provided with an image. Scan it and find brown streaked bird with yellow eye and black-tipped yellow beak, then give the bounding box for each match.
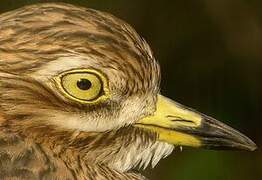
[0,3,256,180]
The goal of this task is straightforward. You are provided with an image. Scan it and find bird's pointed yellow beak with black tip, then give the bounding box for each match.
[135,95,257,151]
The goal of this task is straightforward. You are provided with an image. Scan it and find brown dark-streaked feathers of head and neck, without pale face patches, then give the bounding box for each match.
[0,4,162,179]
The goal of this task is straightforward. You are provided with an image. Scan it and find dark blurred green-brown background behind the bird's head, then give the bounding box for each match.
[0,0,262,180]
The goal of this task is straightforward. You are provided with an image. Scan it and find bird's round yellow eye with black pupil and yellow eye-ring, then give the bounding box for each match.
[56,70,108,103]
